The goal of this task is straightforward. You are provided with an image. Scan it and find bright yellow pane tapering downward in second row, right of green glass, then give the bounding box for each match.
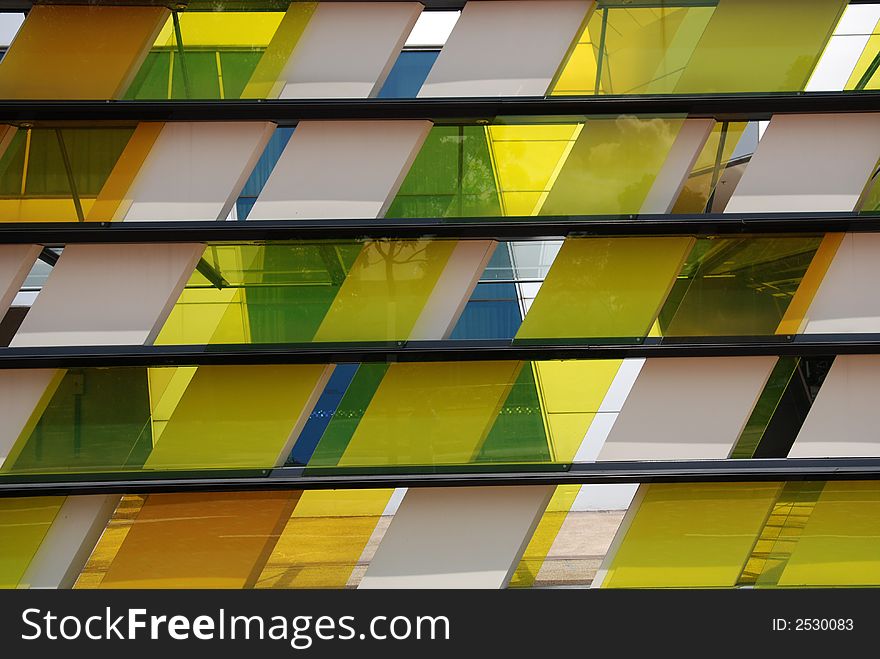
[486,124,583,216]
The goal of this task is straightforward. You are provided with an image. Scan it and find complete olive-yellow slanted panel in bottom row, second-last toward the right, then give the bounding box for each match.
[603,483,781,588]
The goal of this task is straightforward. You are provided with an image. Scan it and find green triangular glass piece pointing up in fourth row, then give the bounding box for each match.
[475,364,551,462]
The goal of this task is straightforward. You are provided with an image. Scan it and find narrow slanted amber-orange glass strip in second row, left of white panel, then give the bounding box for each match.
[88,122,165,222]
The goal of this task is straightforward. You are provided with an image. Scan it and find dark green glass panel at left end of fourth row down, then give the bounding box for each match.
[3,368,152,473]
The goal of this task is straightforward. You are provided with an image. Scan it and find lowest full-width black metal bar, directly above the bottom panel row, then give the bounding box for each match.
[0,458,880,497]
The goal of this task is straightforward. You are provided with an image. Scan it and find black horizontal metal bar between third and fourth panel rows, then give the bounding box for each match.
[0,334,880,369]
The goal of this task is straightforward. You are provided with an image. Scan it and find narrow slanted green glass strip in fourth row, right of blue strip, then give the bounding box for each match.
[309,364,388,467]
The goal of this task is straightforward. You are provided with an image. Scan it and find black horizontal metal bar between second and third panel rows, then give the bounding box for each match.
[0,213,880,247]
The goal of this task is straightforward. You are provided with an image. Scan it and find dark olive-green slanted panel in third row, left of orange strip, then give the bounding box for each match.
[659,236,821,336]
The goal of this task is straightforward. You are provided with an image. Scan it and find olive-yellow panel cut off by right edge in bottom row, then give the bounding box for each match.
[779,481,880,586]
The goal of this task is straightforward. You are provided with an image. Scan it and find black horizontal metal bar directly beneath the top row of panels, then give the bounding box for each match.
[0,90,880,124]
